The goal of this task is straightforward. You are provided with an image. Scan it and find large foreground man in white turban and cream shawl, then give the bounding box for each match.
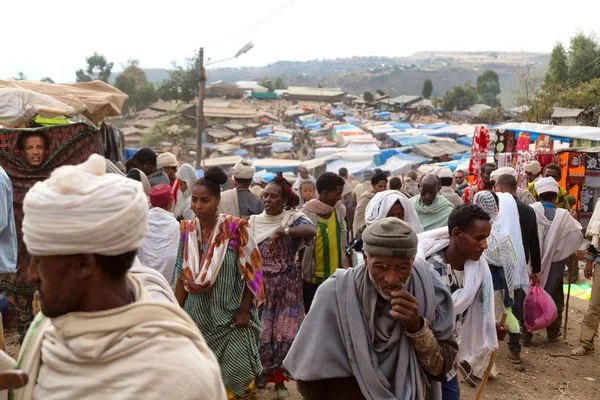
[4,155,225,400]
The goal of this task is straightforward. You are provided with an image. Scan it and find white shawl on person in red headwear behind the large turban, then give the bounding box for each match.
[138,207,180,282]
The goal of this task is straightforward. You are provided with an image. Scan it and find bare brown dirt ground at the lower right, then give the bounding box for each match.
[259,298,600,400]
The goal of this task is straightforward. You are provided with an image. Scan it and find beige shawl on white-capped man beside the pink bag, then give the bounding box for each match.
[531,202,583,287]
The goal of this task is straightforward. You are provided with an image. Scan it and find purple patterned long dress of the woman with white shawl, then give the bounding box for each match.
[258,218,312,383]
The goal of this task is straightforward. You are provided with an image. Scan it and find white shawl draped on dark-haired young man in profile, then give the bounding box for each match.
[417,228,498,364]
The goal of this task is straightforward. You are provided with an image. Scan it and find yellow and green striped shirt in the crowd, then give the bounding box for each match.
[312,212,342,284]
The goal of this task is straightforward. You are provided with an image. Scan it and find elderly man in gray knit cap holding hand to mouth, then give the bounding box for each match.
[284,218,458,400]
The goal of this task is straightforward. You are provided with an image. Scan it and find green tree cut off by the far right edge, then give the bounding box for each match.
[567,31,600,87]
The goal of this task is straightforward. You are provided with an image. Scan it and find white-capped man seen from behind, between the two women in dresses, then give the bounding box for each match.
[219,160,263,220]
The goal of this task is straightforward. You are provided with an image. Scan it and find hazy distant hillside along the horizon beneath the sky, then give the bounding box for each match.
[146,51,550,107]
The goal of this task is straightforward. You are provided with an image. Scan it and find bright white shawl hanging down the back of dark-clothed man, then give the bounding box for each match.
[496,193,529,289]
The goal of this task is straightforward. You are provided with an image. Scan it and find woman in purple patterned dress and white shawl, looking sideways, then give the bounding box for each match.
[249,174,317,398]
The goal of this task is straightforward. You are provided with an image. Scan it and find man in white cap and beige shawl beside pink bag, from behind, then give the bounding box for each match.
[531,177,583,341]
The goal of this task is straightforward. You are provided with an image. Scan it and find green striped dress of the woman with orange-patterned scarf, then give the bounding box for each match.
[176,245,262,398]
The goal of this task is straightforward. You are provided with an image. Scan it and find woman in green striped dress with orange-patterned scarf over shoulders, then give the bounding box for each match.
[175,168,264,400]
